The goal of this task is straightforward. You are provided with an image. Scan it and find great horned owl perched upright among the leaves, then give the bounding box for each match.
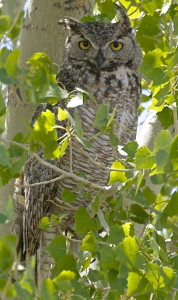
[13,4,142,282]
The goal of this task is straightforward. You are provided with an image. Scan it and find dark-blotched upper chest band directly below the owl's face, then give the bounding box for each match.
[74,66,140,105]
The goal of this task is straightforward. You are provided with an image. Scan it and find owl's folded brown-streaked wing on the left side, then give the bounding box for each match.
[13,104,64,261]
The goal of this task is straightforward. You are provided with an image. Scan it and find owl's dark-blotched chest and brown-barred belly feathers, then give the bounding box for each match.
[59,66,140,183]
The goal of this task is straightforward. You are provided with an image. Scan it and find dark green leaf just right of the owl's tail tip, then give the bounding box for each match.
[46,235,66,261]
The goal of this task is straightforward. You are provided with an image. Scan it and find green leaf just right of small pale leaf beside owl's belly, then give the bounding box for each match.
[135,146,154,169]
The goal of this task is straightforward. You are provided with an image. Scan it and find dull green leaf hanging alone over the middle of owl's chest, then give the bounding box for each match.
[93,104,108,131]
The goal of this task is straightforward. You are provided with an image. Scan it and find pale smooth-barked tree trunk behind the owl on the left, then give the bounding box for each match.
[0,0,94,234]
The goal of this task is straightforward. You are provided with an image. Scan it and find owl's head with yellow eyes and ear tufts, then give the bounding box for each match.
[58,6,142,70]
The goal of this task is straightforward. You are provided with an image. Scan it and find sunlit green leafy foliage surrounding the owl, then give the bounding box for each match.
[0,0,178,300]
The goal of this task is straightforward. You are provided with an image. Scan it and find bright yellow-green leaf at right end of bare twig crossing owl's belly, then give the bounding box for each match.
[108,160,127,185]
